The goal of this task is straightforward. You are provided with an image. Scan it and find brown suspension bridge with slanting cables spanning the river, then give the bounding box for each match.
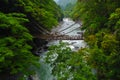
[34,23,84,40]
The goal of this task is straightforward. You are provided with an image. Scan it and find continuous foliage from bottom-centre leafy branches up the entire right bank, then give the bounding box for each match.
[46,0,120,80]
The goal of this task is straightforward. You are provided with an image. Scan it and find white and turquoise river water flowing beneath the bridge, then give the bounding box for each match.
[34,18,86,80]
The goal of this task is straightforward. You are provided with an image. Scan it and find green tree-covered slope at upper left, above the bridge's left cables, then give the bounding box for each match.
[0,0,63,30]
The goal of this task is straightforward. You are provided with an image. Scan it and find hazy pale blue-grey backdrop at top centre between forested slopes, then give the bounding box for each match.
[55,0,77,9]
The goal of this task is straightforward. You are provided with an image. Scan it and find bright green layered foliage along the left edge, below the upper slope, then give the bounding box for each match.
[0,12,38,78]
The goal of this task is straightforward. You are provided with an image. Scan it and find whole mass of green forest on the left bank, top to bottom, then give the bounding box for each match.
[0,0,62,80]
